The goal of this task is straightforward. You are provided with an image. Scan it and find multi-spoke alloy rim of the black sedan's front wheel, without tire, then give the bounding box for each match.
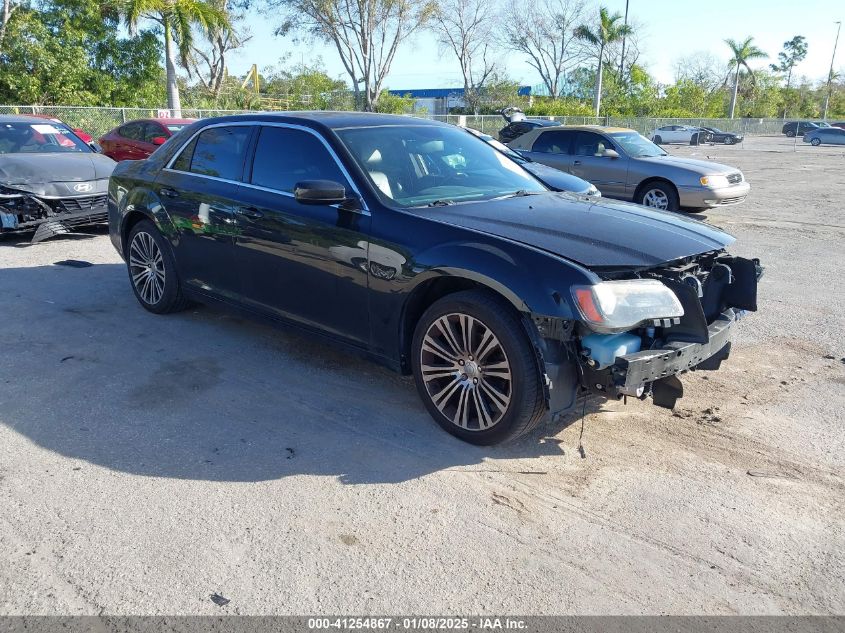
[420,313,513,431]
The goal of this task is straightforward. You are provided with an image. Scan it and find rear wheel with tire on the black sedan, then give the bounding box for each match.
[126,220,189,314]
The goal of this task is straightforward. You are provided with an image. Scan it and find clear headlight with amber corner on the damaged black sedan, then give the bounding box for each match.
[572,279,684,332]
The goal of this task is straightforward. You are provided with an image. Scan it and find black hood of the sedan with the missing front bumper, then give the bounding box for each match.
[420,192,734,268]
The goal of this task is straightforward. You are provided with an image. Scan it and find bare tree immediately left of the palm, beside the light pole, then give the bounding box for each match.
[497,0,584,99]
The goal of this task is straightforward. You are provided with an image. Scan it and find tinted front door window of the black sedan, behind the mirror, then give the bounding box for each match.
[250,127,349,193]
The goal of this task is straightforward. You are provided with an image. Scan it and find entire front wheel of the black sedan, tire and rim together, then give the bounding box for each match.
[411,290,546,446]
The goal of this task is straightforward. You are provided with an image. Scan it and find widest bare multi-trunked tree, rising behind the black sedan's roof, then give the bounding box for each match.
[270,0,436,112]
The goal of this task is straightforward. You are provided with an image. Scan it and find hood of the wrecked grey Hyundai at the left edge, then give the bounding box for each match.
[0,152,116,195]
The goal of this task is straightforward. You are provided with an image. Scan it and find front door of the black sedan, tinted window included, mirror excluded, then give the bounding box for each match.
[235,124,370,346]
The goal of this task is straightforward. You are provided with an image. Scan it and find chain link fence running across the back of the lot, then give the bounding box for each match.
[0,105,796,138]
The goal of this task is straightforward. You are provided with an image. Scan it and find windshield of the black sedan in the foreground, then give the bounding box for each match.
[337,124,548,207]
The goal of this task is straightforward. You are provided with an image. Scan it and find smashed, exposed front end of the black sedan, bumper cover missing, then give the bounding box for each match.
[575,252,763,409]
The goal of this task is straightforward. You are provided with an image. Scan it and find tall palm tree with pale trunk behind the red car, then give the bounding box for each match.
[120,0,231,117]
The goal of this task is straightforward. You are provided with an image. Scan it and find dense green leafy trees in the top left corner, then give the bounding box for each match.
[0,0,164,106]
